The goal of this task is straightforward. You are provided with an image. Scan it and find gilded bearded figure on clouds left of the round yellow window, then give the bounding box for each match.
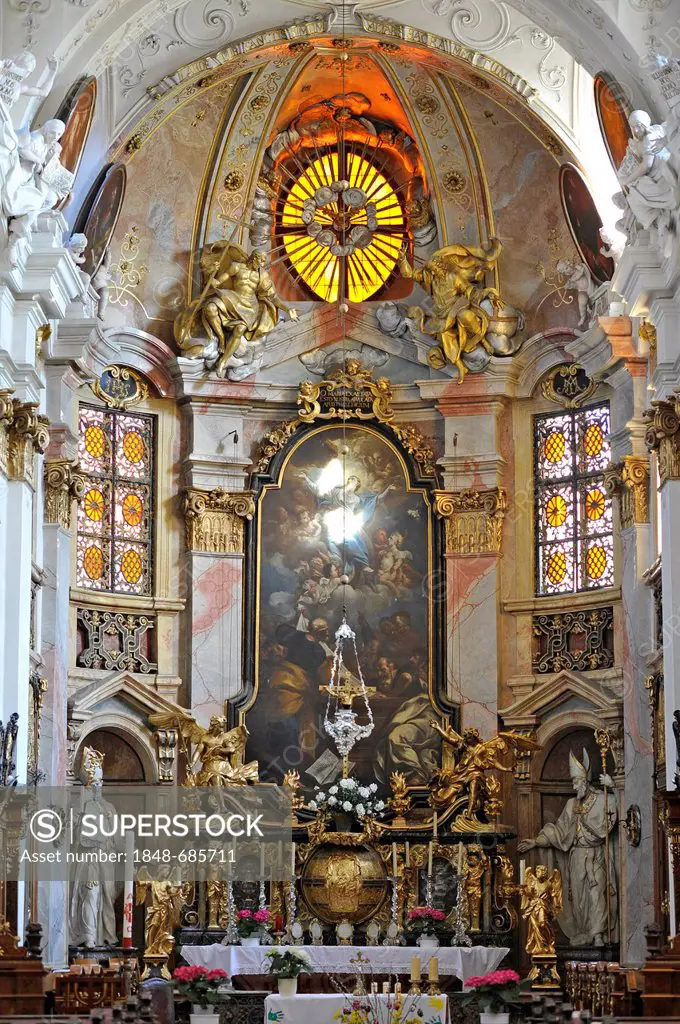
[174,242,298,381]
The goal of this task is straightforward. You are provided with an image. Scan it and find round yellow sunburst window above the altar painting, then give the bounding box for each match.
[280,147,407,302]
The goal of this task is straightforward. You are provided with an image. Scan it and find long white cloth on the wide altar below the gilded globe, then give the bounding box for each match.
[181,942,510,984]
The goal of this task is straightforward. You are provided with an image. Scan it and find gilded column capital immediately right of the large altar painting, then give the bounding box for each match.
[434,487,508,555]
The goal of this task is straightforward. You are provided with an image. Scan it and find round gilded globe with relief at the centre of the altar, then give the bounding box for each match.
[301,843,387,925]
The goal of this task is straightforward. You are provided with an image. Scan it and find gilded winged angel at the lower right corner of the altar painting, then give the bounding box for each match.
[430,721,539,821]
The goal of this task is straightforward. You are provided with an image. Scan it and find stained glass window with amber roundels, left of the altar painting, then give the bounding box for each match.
[77,406,154,594]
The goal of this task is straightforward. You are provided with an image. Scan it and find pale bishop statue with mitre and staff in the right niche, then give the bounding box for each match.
[517,750,618,946]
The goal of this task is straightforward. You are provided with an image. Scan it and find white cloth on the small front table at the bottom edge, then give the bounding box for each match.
[264,993,449,1024]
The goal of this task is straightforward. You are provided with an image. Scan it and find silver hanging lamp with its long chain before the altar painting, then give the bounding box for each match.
[324,9,374,778]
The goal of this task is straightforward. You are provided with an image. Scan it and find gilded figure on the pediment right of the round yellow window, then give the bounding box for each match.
[398,239,503,384]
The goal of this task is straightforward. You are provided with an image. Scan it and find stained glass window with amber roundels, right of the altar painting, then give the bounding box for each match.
[534,404,613,594]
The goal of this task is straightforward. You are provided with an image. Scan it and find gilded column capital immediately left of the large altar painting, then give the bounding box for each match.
[184,487,255,554]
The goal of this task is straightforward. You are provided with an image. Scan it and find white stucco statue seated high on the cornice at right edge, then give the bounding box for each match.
[617,111,680,256]
